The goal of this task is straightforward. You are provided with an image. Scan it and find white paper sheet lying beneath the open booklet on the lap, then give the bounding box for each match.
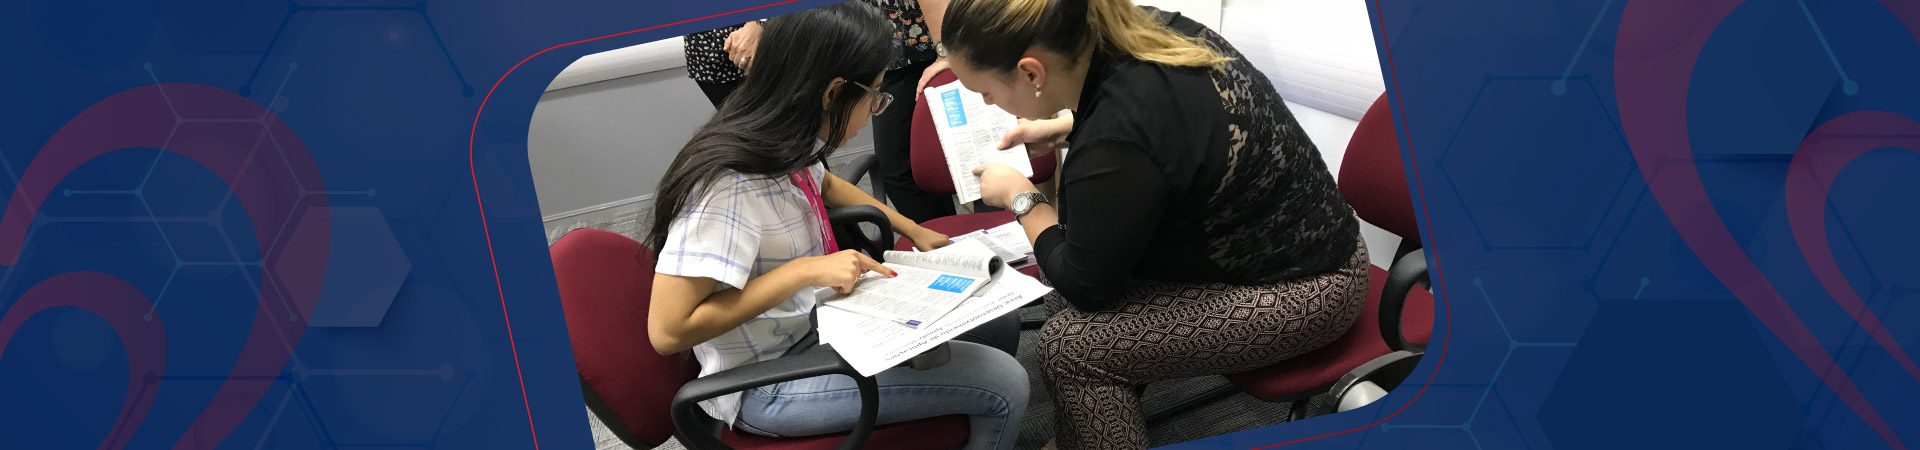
[816,259,1052,377]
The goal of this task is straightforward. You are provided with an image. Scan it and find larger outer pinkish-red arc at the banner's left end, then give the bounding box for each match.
[0,83,330,448]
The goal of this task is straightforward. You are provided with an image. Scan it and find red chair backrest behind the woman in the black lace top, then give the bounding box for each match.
[1340,94,1421,244]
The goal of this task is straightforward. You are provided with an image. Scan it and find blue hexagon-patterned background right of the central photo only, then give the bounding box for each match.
[1169,0,1920,448]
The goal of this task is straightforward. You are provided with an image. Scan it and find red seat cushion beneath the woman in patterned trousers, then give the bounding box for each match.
[1227,267,1434,402]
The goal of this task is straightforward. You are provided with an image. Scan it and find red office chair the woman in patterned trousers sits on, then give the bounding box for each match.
[1150,94,1434,419]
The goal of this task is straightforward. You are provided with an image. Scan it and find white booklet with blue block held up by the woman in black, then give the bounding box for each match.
[927,81,1033,202]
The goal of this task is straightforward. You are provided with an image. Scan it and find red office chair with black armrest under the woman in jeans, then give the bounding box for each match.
[551,229,968,450]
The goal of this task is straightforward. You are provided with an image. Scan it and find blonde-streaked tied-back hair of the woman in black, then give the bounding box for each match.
[941,0,1233,71]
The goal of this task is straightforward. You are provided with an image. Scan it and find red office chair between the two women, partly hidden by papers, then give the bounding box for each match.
[893,71,1056,277]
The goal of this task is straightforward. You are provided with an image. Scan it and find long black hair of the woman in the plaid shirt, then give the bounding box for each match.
[647,2,900,252]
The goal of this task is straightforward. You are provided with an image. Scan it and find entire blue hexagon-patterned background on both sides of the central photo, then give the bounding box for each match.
[0,0,1920,448]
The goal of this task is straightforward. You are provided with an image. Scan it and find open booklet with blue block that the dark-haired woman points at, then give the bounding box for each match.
[820,240,1004,327]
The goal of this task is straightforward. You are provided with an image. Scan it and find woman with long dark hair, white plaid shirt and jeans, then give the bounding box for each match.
[647,2,1027,448]
